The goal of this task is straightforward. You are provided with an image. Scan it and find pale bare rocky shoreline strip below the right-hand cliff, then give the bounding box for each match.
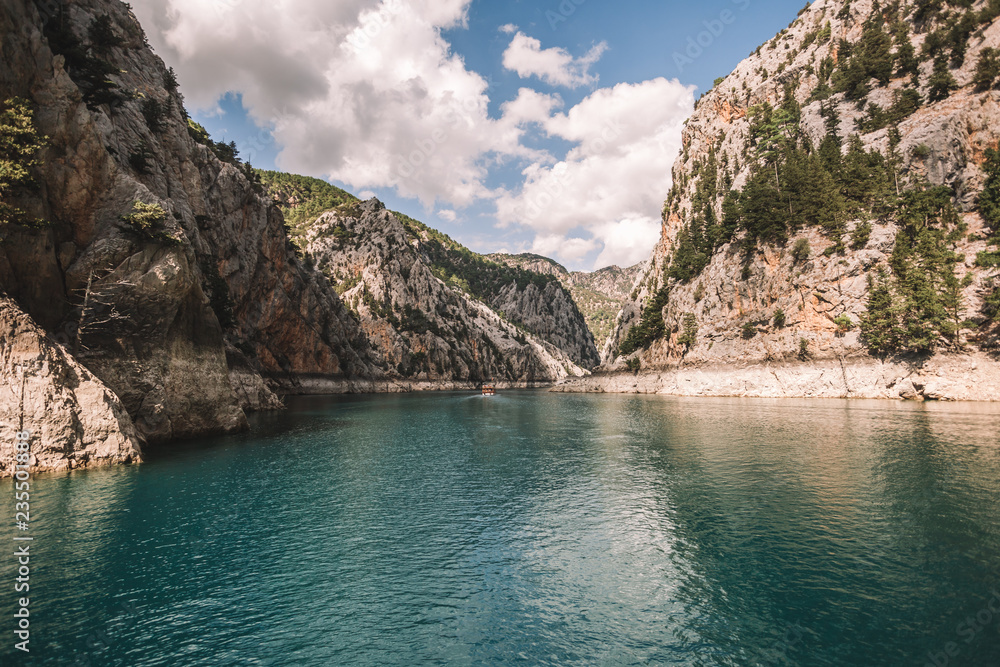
[552,353,1000,402]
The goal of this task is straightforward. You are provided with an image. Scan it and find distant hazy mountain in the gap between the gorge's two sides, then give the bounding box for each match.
[488,253,643,348]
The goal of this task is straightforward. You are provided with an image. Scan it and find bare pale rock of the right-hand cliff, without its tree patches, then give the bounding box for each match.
[602,0,1000,386]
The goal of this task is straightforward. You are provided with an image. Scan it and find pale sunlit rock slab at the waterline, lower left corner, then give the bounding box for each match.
[0,298,142,477]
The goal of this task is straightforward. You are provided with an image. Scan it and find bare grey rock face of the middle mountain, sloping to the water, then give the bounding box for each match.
[305,200,584,383]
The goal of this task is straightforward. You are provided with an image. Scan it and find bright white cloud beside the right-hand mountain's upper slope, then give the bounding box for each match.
[497,78,694,266]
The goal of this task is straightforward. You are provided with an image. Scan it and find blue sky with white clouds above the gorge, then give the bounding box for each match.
[132,0,805,270]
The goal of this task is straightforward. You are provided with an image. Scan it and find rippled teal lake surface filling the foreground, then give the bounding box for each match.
[0,392,1000,667]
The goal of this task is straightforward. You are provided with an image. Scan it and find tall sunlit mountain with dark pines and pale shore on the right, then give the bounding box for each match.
[564,0,1000,400]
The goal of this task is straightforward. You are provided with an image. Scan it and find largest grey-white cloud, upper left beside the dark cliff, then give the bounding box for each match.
[128,0,524,208]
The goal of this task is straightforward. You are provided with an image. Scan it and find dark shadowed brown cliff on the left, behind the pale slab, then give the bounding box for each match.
[0,0,378,442]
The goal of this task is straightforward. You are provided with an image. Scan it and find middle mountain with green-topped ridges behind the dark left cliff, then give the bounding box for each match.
[260,172,600,374]
